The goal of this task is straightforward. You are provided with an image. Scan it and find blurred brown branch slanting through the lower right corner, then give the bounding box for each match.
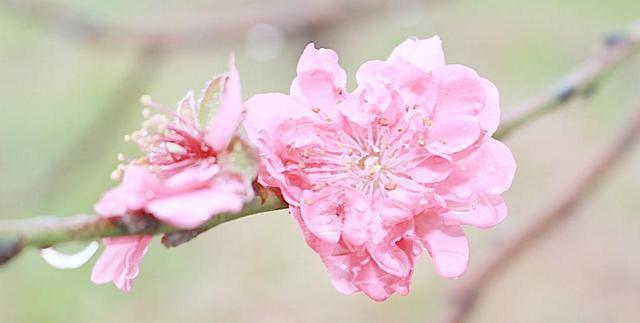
[441,106,640,323]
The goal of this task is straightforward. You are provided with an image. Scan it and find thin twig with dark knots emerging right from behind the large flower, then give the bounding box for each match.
[495,22,640,138]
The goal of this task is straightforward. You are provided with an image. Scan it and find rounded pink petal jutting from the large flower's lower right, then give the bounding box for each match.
[416,214,469,278]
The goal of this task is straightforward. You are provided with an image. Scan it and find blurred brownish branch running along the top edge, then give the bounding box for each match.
[0,0,408,50]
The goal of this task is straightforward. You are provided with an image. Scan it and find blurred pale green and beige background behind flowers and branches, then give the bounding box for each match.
[0,0,640,323]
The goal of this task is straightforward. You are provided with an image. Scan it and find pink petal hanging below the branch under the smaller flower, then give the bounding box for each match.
[91,236,152,292]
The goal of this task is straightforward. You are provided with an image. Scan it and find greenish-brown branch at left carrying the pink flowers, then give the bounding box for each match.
[0,191,287,265]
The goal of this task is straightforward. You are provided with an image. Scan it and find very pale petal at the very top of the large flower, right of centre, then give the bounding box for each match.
[389,36,445,72]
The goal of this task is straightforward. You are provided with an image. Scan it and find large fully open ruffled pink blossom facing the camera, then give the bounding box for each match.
[245,37,516,300]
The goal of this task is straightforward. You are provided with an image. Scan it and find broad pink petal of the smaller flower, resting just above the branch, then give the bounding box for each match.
[146,181,244,229]
